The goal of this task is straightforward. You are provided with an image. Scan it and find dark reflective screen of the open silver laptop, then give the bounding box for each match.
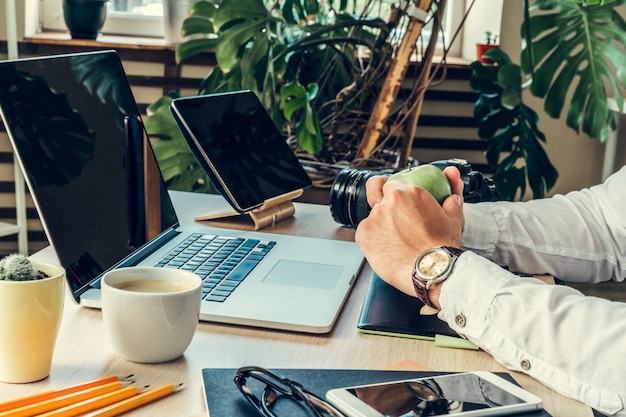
[0,51,177,292]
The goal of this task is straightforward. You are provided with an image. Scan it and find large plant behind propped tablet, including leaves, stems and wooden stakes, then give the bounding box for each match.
[146,0,458,191]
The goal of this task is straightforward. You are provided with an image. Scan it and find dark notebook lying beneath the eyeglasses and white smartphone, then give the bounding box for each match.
[202,368,550,417]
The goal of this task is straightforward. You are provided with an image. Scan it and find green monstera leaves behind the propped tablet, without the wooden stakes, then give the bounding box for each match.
[146,0,390,189]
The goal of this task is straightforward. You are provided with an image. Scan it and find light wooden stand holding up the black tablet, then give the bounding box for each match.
[195,189,303,230]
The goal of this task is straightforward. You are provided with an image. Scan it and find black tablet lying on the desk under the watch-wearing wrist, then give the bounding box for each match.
[357,273,458,339]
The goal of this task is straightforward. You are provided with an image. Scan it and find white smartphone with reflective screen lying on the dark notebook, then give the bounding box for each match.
[326,371,543,417]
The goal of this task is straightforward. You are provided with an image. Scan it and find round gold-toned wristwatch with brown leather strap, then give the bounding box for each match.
[412,246,464,310]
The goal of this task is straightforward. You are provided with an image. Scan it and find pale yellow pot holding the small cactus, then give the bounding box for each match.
[0,263,65,383]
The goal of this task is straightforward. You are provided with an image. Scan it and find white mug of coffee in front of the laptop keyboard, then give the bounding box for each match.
[101,267,202,363]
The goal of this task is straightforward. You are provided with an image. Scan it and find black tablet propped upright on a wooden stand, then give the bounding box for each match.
[170,91,311,213]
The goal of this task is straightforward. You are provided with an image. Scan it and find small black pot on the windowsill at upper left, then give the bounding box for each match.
[63,0,109,39]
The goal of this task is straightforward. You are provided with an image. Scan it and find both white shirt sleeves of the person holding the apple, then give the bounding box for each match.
[439,168,626,416]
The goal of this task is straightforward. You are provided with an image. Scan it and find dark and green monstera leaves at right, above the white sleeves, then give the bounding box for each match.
[471,0,626,200]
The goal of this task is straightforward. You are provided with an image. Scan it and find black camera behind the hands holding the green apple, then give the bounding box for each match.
[330,158,500,227]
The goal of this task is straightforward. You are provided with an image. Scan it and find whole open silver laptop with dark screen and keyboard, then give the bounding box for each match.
[0,51,364,334]
